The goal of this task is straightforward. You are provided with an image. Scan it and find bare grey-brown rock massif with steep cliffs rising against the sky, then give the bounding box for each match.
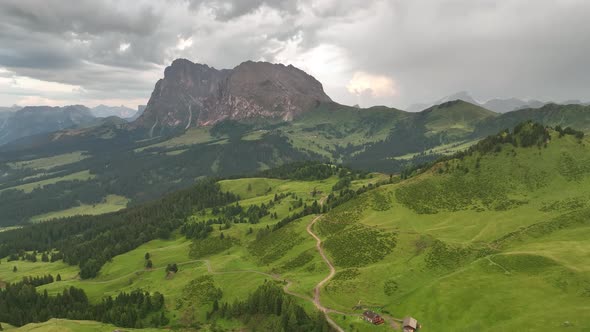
[135,59,331,131]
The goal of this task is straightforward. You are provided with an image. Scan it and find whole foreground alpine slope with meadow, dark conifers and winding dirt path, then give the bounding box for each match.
[0,122,590,331]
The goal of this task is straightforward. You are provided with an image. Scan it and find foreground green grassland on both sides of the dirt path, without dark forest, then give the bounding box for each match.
[0,123,590,331]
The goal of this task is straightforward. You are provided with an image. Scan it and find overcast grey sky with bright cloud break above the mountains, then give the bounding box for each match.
[0,0,590,108]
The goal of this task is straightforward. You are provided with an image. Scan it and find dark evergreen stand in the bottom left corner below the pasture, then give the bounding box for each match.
[0,282,168,328]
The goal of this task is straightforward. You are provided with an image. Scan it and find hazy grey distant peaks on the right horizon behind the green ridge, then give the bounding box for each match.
[406,91,590,113]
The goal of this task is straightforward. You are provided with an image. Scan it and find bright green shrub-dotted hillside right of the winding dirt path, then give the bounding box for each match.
[319,126,590,331]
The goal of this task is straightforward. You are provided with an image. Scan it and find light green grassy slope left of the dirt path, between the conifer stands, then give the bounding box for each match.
[0,171,383,330]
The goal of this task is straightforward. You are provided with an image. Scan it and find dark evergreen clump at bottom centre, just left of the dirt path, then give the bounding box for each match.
[208,281,332,332]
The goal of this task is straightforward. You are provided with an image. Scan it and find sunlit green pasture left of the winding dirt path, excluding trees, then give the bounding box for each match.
[0,177,377,327]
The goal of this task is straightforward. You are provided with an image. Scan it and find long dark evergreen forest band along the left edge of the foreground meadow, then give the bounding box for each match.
[0,180,237,279]
